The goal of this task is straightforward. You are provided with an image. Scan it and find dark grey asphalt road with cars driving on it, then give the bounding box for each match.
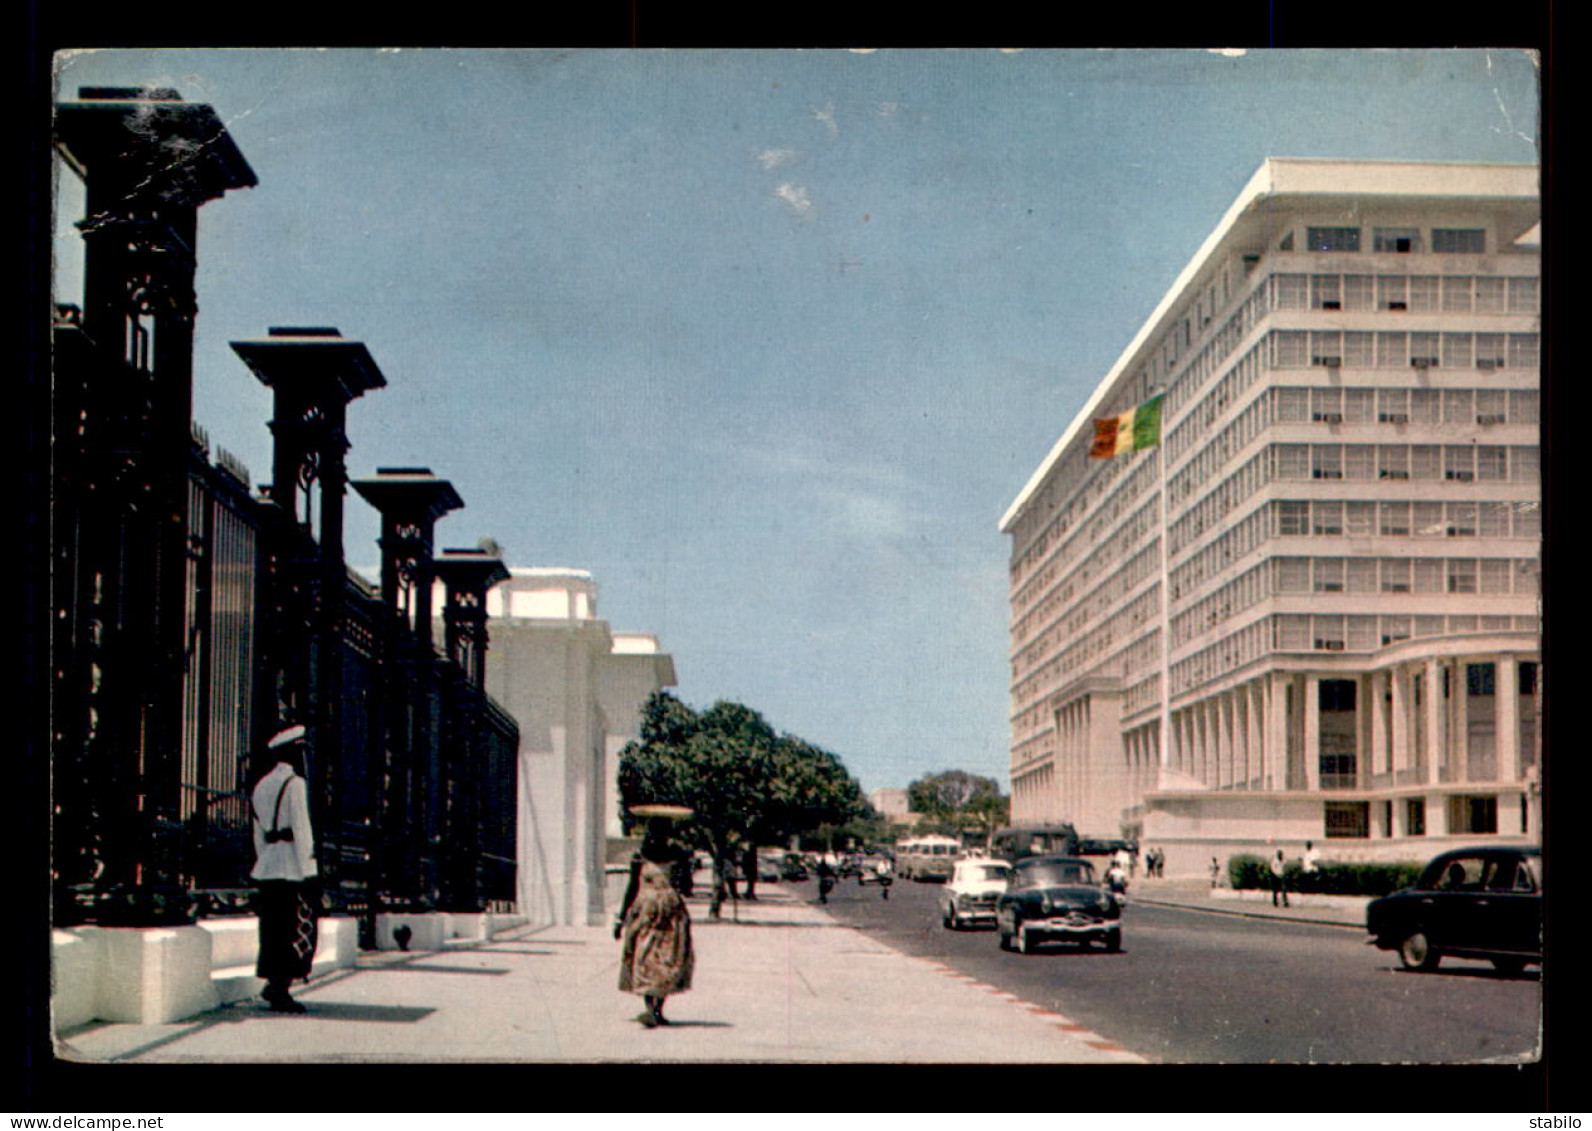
[808,879,1541,1064]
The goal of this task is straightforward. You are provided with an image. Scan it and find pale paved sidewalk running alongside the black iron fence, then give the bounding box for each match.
[57,881,1146,1064]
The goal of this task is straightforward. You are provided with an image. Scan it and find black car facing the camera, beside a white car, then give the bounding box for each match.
[995,855,1122,954]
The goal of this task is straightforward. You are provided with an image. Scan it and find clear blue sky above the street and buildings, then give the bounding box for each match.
[57,49,1538,790]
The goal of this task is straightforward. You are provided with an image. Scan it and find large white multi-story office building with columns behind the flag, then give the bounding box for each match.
[1001,159,1543,868]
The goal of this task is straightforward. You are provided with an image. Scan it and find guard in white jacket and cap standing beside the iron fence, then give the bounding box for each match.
[248,726,320,1013]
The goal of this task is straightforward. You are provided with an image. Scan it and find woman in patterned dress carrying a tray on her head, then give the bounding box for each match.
[618,806,696,1029]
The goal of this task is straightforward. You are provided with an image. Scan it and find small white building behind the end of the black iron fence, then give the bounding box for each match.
[468,567,675,924]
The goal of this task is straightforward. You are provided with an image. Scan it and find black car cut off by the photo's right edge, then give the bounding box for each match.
[1366,846,1543,973]
